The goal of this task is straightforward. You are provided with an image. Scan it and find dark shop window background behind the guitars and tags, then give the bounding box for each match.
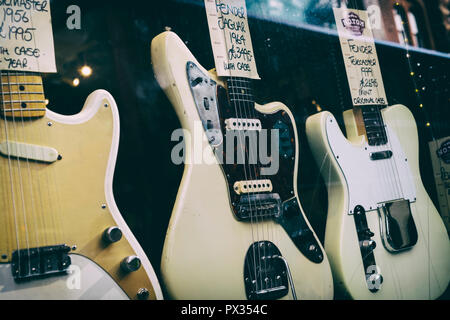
[40,0,450,296]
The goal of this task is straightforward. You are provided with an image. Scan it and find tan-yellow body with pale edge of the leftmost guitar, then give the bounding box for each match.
[0,90,162,299]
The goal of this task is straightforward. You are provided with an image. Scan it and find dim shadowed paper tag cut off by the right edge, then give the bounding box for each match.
[428,137,450,231]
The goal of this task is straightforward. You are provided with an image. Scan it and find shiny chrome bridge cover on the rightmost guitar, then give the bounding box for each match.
[378,200,418,252]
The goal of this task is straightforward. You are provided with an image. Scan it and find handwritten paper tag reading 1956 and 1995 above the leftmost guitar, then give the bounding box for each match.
[0,0,56,72]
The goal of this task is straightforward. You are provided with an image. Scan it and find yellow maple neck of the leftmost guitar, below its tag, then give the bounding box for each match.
[0,71,46,120]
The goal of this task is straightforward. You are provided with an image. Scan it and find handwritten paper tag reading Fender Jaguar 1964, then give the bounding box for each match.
[205,0,259,79]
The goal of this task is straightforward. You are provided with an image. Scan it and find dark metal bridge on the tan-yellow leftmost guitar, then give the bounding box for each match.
[11,244,71,281]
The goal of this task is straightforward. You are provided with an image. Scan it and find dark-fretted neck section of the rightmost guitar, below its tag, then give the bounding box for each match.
[353,105,388,146]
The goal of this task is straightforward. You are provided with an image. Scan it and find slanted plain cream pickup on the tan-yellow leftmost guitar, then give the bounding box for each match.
[0,141,59,163]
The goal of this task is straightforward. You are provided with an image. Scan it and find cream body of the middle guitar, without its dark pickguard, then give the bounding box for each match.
[152,32,333,299]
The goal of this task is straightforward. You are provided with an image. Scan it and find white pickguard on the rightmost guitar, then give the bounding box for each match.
[326,115,416,214]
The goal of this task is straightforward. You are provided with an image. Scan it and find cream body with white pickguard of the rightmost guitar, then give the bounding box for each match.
[306,105,450,299]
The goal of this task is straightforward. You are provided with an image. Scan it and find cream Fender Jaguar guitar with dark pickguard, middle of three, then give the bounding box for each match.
[151,32,333,299]
